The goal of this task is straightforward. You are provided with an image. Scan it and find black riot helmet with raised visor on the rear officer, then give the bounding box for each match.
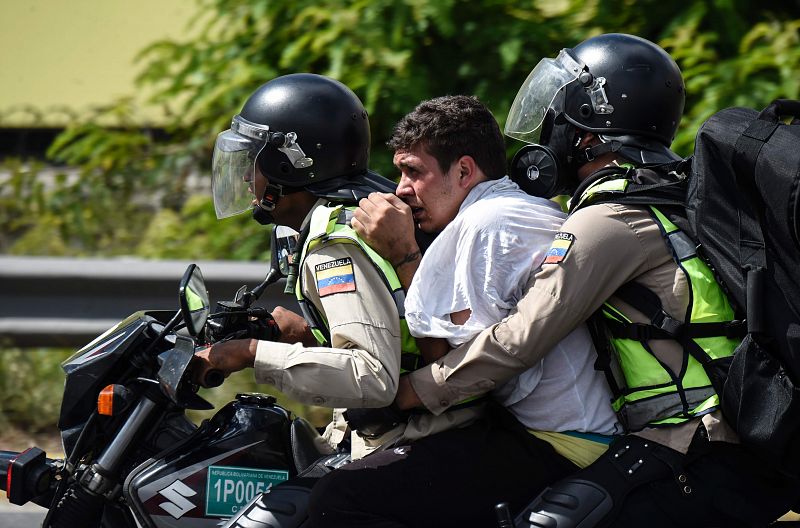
[505,33,685,196]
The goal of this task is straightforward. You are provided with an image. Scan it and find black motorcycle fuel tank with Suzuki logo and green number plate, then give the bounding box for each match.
[123,394,296,528]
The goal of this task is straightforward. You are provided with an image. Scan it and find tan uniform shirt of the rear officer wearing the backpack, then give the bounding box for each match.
[411,204,735,451]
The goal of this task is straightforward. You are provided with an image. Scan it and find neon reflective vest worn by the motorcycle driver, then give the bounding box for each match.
[295,205,422,372]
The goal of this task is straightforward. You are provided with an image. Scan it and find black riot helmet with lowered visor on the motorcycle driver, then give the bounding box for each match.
[212,73,394,223]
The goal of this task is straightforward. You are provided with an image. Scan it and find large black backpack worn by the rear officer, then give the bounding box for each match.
[686,100,800,474]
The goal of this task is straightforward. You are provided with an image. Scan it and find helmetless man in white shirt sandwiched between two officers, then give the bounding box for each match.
[311,96,617,527]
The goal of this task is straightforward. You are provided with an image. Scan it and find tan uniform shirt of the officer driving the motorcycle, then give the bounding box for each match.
[255,212,477,459]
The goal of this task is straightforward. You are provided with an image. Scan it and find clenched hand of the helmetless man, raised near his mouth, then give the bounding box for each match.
[351,193,420,268]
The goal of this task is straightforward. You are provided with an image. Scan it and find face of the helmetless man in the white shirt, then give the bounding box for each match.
[392,146,468,233]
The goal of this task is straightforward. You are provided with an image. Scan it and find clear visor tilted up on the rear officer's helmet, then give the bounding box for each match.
[504,50,583,144]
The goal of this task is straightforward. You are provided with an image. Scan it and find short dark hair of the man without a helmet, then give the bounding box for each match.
[386,95,506,180]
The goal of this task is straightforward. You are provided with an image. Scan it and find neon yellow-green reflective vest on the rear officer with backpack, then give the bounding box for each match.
[578,180,739,431]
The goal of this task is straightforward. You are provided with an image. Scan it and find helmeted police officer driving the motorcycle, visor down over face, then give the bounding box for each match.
[197,74,438,457]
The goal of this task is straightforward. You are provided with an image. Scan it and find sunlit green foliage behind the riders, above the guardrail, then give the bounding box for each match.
[0,0,800,259]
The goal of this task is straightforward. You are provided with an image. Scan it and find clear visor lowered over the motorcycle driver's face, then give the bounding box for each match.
[211,130,266,218]
